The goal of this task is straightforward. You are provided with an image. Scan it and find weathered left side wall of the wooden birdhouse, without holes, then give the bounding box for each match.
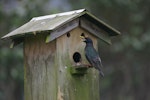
[24,34,57,100]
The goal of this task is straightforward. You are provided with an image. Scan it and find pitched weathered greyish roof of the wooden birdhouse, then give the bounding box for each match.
[2,9,120,39]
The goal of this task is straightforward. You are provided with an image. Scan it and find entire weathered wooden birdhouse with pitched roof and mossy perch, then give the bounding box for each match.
[3,9,119,100]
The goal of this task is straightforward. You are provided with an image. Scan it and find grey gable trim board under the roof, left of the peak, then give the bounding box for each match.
[46,18,79,43]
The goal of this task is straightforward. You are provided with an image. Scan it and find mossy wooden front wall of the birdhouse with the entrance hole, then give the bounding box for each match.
[56,27,100,100]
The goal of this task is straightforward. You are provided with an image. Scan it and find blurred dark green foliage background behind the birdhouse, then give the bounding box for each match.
[0,0,150,100]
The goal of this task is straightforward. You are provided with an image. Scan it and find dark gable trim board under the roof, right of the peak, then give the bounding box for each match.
[80,17,111,44]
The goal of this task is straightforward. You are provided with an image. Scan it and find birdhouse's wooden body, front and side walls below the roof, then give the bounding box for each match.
[24,28,100,100]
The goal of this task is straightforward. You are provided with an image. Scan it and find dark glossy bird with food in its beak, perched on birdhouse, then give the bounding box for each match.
[80,35,104,77]
